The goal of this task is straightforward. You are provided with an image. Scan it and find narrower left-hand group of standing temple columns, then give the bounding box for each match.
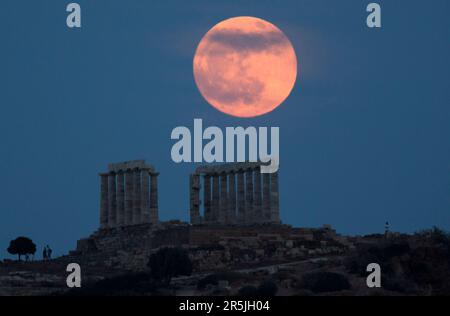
[100,160,159,229]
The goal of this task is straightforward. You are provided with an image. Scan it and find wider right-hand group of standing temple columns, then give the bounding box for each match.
[190,163,280,225]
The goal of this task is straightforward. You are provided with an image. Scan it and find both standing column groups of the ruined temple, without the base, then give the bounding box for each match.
[100,160,280,229]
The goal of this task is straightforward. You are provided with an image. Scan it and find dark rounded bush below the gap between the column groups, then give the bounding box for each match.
[148,248,192,284]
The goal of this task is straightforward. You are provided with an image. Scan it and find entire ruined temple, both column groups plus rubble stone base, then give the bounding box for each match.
[73,160,349,272]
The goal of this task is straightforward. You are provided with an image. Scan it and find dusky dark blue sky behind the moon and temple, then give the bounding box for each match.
[0,0,450,257]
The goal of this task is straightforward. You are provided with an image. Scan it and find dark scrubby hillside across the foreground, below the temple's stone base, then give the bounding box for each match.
[0,229,450,296]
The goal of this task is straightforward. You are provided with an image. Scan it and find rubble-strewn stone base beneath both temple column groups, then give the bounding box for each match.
[72,224,348,271]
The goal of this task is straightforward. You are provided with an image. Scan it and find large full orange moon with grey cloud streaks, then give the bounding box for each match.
[194,16,297,117]
